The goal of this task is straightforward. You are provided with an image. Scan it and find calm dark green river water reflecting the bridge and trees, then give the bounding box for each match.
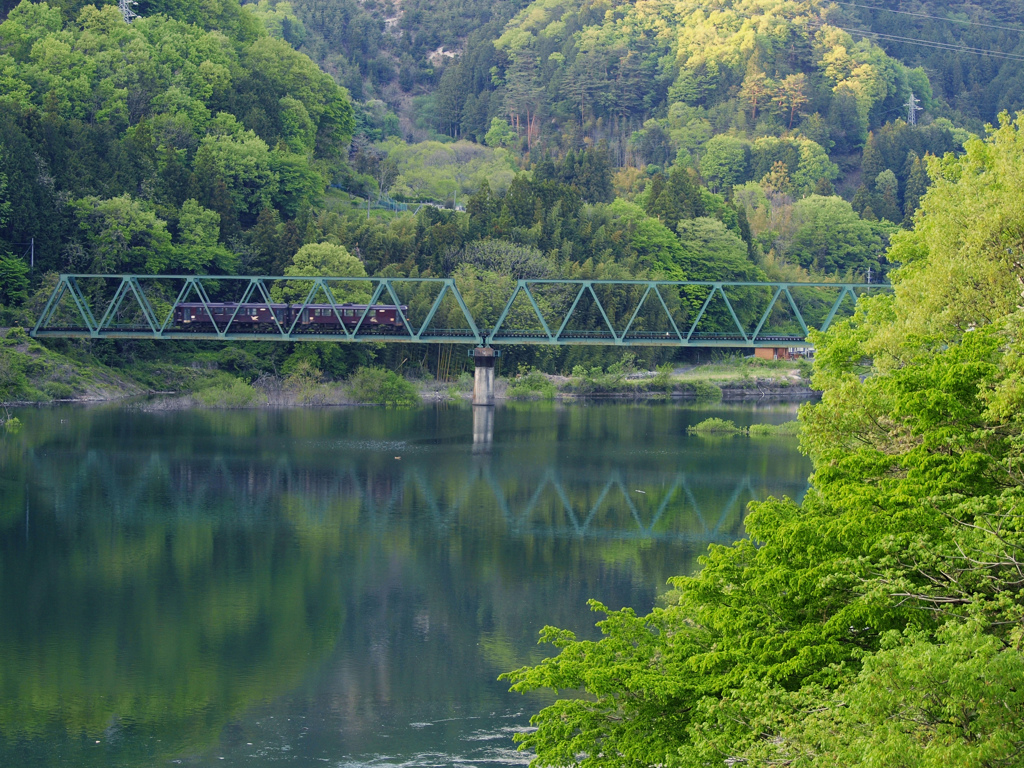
[0,403,810,768]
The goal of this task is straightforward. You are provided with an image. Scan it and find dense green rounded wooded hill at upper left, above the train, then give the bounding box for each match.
[0,2,354,271]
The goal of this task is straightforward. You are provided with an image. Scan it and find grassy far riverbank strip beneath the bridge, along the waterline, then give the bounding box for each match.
[0,328,816,410]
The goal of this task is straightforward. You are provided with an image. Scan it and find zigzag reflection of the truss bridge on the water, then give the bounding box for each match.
[32,451,805,544]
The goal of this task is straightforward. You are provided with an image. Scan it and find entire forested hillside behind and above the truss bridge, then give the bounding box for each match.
[0,0,1024,391]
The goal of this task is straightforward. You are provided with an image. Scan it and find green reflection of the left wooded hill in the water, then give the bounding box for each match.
[0,456,341,765]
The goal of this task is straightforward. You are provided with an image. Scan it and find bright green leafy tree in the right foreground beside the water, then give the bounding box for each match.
[505,115,1024,768]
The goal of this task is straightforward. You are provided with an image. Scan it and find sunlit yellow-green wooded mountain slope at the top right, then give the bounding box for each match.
[428,0,935,156]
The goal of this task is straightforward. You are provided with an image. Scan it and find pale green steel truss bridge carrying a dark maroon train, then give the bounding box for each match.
[31,274,891,347]
